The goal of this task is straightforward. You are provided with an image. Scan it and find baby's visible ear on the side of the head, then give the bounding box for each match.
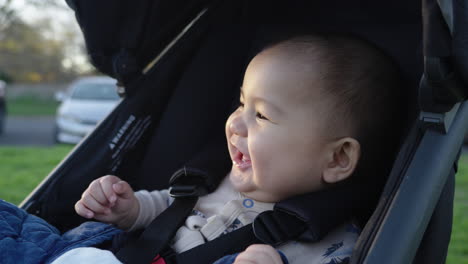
[322,137,361,183]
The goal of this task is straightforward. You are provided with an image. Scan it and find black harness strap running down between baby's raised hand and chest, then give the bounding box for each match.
[115,196,198,263]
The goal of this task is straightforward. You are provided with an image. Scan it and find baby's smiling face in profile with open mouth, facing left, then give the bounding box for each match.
[226,50,330,202]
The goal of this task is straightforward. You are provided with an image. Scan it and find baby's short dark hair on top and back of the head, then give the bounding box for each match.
[264,33,407,183]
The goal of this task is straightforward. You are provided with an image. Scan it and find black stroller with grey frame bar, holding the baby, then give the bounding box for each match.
[21,0,468,263]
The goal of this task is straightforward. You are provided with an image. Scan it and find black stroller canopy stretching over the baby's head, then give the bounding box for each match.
[67,0,422,91]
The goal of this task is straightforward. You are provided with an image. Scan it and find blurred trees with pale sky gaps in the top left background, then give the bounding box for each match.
[0,0,89,82]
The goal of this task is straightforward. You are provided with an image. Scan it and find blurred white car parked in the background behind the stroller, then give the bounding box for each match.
[55,76,120,144]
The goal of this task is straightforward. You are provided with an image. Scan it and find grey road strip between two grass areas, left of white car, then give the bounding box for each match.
[0,116,55,146]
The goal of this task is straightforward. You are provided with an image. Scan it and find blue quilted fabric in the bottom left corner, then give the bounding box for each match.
[0,200,121,264]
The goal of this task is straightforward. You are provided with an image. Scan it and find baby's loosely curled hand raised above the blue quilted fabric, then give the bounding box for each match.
[75,175,139,229]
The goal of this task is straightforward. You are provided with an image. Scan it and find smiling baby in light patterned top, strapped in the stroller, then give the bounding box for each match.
[68,34,403,263]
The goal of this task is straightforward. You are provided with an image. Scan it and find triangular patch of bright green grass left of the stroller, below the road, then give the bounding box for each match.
[0,145,73,204]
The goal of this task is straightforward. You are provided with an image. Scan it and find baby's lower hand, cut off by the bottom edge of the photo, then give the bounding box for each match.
[234,244,283,264]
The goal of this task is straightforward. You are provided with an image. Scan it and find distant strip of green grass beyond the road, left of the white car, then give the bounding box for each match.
[7,95,60,116]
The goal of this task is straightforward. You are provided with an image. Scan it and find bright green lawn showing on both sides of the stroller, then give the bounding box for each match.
[0,145,468,264]
